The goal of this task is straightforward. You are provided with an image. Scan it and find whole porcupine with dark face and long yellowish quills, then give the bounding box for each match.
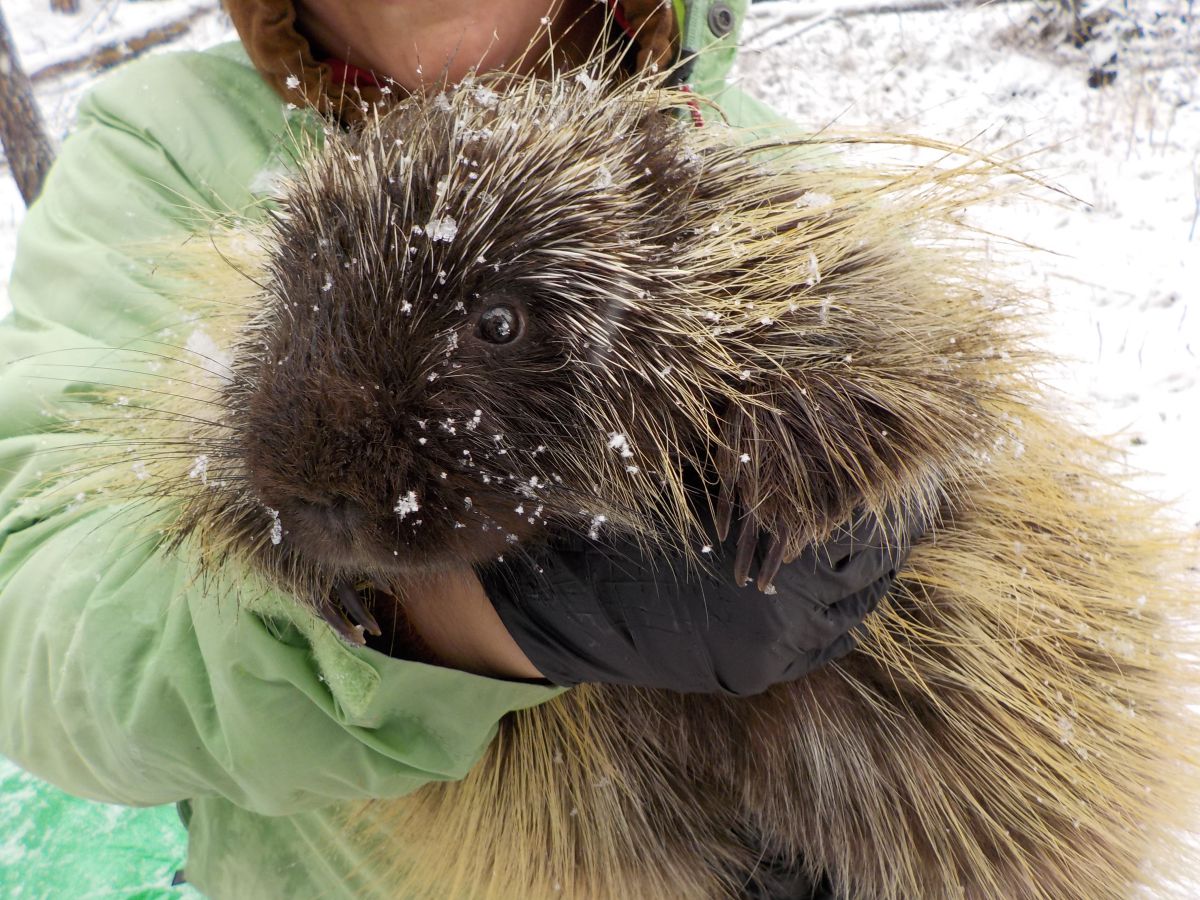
[75,65,1196,900]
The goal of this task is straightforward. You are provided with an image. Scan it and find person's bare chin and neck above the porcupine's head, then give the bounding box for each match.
[296,0,605,91]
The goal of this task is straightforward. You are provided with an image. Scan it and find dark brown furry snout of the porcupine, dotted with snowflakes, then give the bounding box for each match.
[236,303,534,577]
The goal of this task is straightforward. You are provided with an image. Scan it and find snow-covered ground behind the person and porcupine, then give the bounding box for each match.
[0,0,1200,895]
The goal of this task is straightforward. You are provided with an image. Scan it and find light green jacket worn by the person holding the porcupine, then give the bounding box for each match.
[0,2,796,898]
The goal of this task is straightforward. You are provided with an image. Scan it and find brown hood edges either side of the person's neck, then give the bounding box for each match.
[224,0,700,122]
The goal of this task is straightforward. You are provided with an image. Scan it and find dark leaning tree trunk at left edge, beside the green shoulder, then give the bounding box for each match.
[0,2,54,206]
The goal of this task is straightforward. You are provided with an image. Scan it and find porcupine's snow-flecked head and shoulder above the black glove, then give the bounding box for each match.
[142,71,1022,637]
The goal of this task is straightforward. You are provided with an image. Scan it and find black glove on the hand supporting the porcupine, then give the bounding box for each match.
[479,508,920,696]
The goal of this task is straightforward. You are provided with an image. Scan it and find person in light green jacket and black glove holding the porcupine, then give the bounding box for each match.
[0,0,920,896]
